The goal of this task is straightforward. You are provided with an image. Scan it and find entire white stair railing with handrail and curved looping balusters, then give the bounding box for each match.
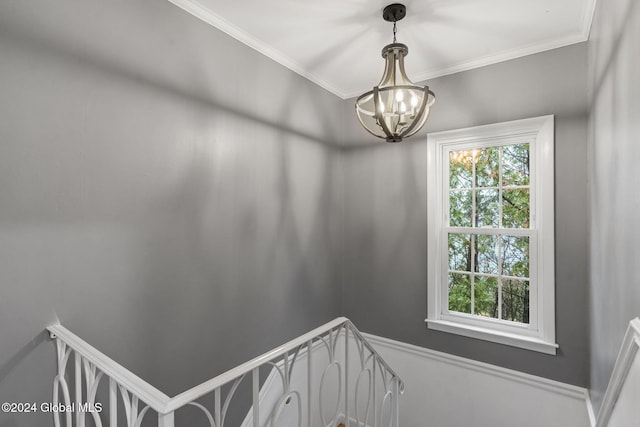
[47,317,404,427]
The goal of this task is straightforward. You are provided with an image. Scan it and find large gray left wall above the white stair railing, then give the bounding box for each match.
[0,0,342,427]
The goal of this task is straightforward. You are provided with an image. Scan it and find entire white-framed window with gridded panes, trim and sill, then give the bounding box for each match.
[426,116,558,354]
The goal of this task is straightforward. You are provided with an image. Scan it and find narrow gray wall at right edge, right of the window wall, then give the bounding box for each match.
[589,0,640,414]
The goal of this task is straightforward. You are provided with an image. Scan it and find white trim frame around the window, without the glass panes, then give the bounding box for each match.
[425,116,558,354]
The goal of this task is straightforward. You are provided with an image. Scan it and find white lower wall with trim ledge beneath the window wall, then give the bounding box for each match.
[364,334,591,427]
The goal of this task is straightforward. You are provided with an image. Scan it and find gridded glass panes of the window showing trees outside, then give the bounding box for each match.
[447,143,531,323]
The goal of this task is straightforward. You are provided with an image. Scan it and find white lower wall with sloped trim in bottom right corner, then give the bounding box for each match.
[595,317,640,427]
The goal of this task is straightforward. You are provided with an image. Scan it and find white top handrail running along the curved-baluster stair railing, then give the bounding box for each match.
[47,317,404,422]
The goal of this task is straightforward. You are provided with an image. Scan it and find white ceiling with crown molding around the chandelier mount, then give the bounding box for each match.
[169,0,596,98]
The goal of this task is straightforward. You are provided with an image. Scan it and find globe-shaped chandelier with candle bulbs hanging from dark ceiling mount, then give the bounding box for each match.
[356,3,436,142]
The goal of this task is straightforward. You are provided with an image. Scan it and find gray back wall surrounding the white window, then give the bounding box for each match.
[342,43,589,386]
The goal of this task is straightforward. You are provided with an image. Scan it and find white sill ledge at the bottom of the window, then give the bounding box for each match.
[425,319,558,356]
